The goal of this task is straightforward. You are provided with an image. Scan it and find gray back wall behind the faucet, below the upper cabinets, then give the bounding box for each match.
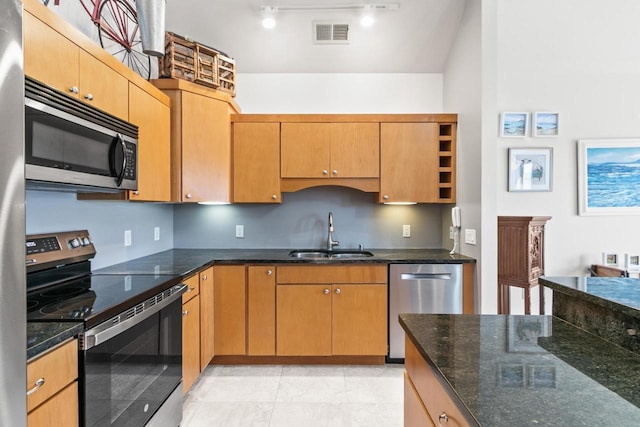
[174,187,442,249]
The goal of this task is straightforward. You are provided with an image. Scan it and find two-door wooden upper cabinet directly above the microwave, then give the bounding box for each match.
[23,2,129,120]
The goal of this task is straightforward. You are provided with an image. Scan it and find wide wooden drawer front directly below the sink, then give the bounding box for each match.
[278,265,387,284]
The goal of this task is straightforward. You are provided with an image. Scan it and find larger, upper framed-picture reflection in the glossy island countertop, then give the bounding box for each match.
[507,315,551,353]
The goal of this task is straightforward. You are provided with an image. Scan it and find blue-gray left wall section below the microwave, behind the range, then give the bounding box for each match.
[26,191,173,269]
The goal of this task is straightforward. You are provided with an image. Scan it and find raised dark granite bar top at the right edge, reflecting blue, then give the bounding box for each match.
[539,276,640,319]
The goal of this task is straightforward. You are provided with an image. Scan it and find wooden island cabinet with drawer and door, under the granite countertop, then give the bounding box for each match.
[404,338,470,427]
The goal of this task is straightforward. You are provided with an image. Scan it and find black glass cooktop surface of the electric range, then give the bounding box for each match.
[27,274,180,328]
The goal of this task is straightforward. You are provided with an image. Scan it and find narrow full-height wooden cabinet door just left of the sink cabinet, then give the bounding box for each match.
[247,265,276,356]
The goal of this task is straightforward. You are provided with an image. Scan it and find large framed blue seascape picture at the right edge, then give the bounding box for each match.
[578,139,640,215]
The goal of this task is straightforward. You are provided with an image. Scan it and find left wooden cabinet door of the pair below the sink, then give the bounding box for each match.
[276,285,331,356]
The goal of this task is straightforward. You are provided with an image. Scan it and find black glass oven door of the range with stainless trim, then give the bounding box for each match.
[80,292,182,427]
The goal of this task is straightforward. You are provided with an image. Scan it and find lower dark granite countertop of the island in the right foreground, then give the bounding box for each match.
[400,314,640,427]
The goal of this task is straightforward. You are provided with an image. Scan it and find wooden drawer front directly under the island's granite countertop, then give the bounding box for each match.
[405,338,469,426]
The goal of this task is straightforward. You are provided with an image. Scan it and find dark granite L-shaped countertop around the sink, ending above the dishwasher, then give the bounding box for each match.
[94,249,476,277]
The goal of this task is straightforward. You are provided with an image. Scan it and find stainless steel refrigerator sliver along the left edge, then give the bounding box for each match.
[0,0,27,427]
